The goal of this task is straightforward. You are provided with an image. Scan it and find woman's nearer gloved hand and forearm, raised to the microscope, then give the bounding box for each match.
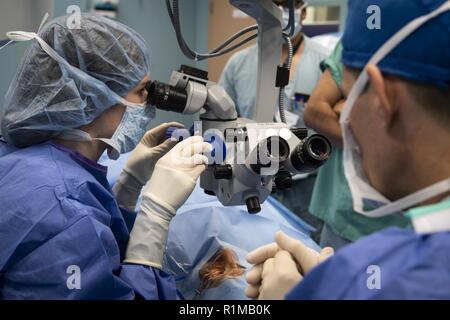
[125,136,212,268]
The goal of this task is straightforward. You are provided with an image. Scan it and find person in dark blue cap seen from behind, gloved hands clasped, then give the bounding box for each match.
[246,0,450,299]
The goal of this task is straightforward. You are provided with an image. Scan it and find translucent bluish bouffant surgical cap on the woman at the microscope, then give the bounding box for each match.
[2,14,149,147]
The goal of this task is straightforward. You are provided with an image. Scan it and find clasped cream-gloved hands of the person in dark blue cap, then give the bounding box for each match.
[245,231,334,299]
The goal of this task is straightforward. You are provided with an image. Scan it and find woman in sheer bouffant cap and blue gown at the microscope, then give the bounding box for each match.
[0,14,210,299]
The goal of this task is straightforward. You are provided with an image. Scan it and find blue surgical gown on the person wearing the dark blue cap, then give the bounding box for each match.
[287,228,450,300]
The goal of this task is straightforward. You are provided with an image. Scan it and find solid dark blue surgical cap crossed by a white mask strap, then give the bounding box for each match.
[342,0,450,88]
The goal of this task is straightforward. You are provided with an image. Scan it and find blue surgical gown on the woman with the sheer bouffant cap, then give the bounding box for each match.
[0,142,176,300]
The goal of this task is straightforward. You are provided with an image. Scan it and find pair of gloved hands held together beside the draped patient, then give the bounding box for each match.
[245,231,334,299]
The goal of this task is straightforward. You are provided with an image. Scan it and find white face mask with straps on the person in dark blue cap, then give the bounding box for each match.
[340,1,450,218]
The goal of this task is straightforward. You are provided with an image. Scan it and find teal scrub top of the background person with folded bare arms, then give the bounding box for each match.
[309,42,410,241]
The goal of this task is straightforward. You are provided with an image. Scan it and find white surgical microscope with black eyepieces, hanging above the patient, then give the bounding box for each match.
[147,0,331,214]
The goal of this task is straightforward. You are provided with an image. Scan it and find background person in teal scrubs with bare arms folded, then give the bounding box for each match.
[305,42,409,250]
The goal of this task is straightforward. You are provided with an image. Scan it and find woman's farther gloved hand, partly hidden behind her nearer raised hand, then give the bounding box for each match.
[113,122,183,211]
